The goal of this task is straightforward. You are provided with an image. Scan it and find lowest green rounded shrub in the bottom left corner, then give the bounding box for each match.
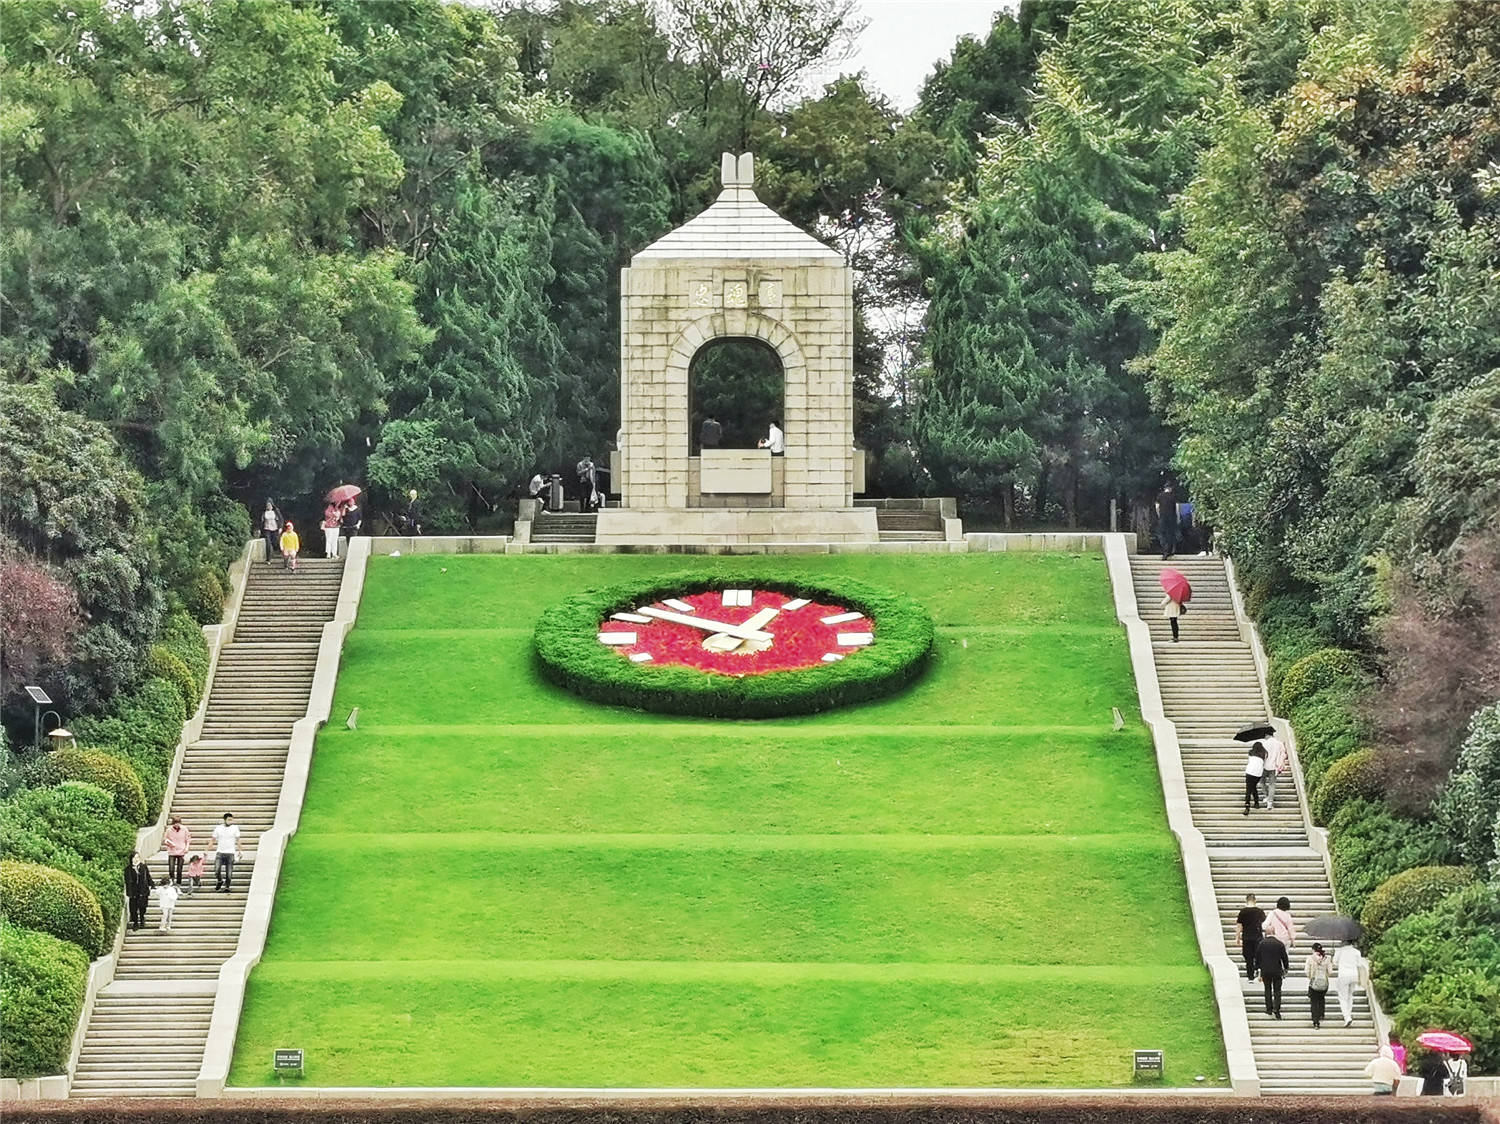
[0,921,89,1077]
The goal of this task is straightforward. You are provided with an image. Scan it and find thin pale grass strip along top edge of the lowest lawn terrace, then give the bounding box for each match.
[246,960,1203,989]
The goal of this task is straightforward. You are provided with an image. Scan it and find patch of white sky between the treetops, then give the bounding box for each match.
[846,0,1019,110]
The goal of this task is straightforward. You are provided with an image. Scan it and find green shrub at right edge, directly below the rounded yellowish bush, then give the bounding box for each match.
[1370,882,1500,1010]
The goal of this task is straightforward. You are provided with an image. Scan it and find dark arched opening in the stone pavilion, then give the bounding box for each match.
[687,336,786,456]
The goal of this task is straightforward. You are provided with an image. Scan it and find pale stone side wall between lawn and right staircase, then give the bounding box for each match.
[1103,531,1260,1097]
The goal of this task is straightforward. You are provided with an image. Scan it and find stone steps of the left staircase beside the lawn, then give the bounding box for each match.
[71,560,344,1097]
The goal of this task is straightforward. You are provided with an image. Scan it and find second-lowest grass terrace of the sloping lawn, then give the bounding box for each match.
[258,836,1199,965]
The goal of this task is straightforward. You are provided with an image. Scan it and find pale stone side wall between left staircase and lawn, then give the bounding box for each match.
[195,536,374,1098]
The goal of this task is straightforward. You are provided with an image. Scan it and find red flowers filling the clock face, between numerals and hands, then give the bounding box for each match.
[599,590,875,675]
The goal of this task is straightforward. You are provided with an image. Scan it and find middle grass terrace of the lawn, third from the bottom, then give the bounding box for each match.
[293,722,1167,851]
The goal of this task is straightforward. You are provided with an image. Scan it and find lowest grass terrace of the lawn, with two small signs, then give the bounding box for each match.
[230,963,1226,1088]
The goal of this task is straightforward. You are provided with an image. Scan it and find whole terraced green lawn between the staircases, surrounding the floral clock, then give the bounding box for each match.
[231,554,1224,1086]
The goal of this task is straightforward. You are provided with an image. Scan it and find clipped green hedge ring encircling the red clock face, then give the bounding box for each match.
[533,570,935,719]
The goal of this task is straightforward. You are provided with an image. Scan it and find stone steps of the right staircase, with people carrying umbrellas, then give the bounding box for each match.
[1131,555,1376,1095]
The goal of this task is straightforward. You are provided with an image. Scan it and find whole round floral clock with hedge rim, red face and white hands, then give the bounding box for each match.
[536,573,933,717]
